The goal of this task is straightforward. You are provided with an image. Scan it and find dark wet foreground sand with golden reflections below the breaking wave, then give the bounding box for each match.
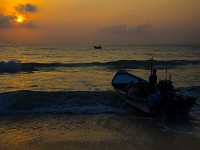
[0,114,200,150]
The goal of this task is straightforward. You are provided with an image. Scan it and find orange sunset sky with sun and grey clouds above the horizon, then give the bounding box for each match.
[0,0,200,44]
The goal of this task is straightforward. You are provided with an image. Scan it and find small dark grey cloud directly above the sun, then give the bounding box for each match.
[15,4,38,13]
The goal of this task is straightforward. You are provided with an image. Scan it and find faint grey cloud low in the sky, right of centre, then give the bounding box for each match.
[101,24,150,35]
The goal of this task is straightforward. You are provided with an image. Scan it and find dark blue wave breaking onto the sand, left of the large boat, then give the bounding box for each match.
[0,91,126,114]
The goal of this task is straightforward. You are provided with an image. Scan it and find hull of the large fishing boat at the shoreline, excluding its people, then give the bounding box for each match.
[112,70,197,115]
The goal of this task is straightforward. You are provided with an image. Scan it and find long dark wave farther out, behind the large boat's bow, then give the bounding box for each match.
[0,60,200,72]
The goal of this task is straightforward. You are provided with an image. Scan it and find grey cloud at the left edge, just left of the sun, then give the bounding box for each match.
[0,15,16,29]
